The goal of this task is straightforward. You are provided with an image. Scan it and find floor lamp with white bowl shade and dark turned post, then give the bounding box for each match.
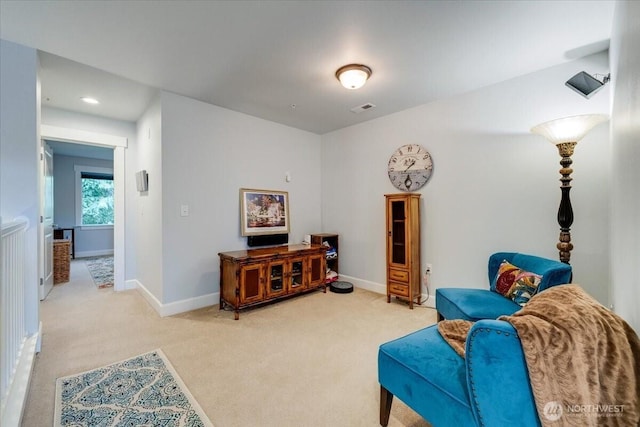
[531,114,609,264]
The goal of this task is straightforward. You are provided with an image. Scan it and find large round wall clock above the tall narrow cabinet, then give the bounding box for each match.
[387,144,433,191]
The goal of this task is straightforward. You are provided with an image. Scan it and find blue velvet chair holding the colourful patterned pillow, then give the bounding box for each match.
[436,252,571,322]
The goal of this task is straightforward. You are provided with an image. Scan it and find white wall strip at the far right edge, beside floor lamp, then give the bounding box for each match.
[611,1,640,333]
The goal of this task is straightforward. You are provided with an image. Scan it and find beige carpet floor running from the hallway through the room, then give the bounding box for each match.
[23,261,436,427]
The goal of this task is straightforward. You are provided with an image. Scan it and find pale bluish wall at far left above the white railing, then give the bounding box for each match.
[0,40,40,334]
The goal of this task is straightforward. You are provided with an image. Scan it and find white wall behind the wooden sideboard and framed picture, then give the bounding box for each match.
[158,92,321,303]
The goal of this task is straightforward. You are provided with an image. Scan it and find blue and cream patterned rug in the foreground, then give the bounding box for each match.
[54,349,212,427]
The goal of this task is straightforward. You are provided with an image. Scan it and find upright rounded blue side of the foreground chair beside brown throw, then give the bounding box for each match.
[465,320,540,426]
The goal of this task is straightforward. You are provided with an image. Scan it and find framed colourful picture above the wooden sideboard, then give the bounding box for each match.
[240,188,289,236]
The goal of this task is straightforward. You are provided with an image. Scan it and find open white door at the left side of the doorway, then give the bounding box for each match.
[40,141,53,300]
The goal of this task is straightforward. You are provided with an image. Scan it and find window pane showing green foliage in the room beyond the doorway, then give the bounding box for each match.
[82,178,113,225]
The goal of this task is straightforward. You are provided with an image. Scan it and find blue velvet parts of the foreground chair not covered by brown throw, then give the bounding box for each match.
[378,320,541,427]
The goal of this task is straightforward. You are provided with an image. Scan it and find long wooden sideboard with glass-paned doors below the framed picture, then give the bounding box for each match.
[218,245,327,320]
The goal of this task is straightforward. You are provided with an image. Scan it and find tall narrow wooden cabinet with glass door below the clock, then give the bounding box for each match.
[385,193,421,309]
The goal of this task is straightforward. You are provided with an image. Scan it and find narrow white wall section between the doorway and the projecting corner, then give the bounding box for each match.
[127,96,164,303]
